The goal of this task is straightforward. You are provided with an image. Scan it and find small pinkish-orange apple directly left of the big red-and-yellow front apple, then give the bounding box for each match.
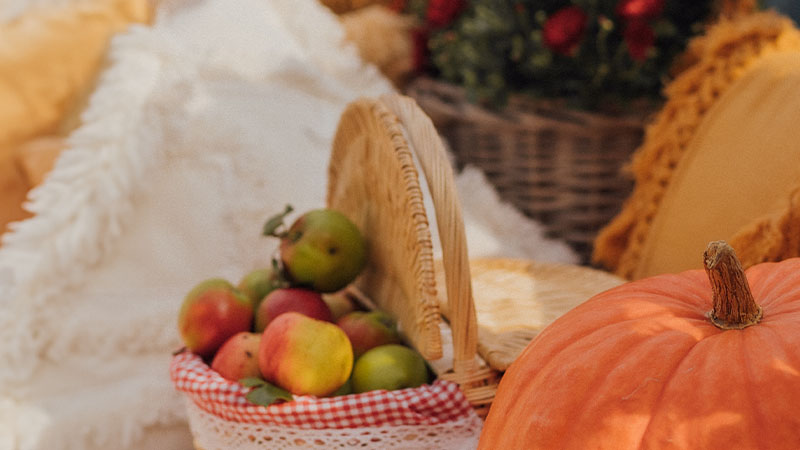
[211,331,261,381]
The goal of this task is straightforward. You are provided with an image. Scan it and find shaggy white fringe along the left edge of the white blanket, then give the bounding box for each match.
[0,27,169,384]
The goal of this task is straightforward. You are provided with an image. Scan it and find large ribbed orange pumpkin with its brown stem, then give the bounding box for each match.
[479,241,800,450]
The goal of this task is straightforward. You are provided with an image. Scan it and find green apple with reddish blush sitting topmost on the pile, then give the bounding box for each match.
[279,208,367,292]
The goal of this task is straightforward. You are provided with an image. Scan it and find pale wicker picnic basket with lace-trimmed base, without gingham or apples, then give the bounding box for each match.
[173,95,624,450]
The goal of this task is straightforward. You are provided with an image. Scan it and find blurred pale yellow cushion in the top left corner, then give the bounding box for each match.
[0,0,151,147]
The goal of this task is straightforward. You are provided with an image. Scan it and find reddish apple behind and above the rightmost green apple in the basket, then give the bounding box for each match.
[336,310,401,358]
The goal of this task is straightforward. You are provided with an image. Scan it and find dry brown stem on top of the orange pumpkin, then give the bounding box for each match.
[703,241,761,330]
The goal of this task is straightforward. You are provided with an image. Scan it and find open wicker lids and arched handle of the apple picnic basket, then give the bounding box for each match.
[327,95,623,416]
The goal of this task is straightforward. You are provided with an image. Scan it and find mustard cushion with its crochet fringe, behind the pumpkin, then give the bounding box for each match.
[593,12,800,279]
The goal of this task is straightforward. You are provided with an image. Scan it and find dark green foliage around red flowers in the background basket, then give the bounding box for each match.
[412,0,711,110]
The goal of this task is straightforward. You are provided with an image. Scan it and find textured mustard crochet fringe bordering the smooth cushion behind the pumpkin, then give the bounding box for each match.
[593,12,800,279]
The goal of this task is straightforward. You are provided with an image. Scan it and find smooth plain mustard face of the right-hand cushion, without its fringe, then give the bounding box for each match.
[634,51,800,278]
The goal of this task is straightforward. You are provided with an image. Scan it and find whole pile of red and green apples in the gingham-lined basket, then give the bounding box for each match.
[178,207,430,406]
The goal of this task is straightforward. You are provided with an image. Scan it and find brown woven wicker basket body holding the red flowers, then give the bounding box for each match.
[406,77,652,263]
